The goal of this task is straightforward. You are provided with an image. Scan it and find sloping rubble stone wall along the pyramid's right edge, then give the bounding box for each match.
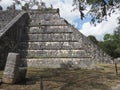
[71,26,113,63]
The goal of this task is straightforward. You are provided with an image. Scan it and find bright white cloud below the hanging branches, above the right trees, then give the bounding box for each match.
[80,11,119,40]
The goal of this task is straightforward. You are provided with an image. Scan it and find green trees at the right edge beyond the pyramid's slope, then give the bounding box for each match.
[99,22,120,58]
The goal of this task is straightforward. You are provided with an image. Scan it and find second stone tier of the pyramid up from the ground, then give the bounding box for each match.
[19,49,88,58]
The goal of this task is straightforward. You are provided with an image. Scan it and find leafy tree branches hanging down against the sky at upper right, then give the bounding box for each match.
[73,0,120,23]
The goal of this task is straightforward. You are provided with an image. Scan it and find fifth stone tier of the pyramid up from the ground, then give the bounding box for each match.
[25,26,73,34]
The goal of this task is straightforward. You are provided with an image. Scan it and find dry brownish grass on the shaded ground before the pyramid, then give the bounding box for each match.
[0,64,120,90]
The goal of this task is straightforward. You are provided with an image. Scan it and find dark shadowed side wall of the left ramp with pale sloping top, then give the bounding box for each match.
[0,11,29,67]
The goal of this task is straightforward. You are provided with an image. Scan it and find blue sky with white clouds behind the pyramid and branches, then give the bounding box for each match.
[0,0,120,40]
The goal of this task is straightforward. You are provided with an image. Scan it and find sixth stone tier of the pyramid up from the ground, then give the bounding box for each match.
[30,19,67,26]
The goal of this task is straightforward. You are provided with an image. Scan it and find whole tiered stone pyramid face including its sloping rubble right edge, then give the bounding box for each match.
[0,9,111,68]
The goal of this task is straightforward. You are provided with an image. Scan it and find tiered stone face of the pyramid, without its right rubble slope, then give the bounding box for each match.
[19,10,112,68]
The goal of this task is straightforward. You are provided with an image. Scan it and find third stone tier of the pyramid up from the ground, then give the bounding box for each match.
[19,42,82,50]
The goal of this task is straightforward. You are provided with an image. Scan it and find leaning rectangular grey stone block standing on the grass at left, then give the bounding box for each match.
[3,53,20,84]
